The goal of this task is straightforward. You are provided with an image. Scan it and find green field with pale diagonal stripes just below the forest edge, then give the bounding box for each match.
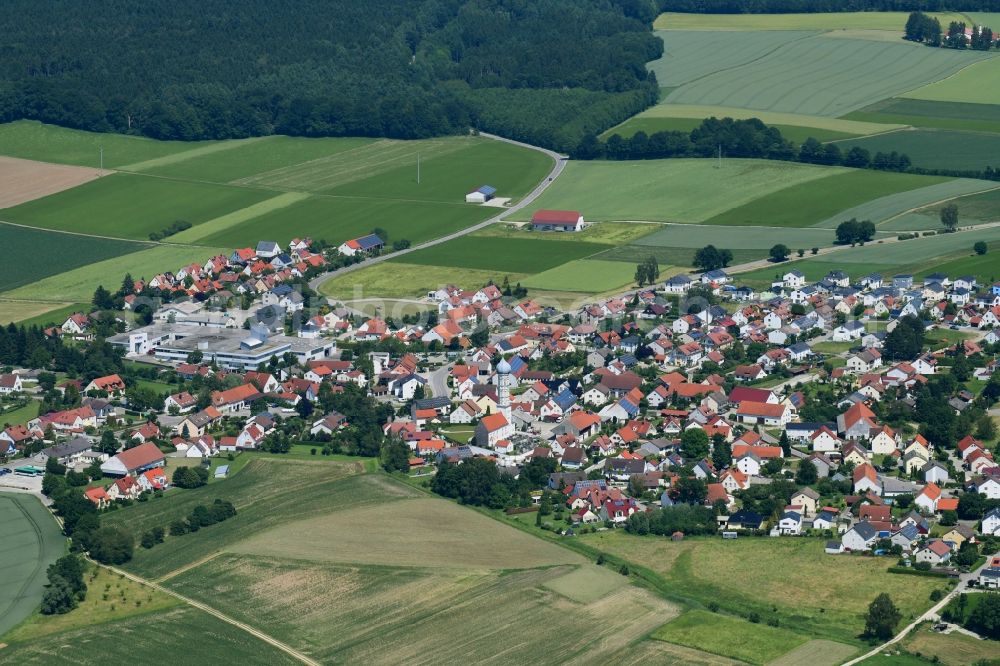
[233,138,469,192]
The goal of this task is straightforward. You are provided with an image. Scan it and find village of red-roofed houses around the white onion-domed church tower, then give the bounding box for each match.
[0,220,1000,588]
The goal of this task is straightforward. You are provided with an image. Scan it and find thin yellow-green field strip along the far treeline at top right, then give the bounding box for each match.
[653,12,967,31]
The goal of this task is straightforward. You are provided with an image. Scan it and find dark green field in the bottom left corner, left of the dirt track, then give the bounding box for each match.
[0,606,300,666]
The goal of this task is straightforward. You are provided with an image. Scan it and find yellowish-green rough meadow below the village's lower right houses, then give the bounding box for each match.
[579,532,941,641]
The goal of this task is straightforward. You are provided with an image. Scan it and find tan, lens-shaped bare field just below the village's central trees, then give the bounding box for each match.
[227,497,583,569]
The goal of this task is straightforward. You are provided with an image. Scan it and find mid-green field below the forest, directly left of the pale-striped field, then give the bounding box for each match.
[137,136,374,183]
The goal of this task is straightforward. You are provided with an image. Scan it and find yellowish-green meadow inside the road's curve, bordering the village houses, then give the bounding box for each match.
[320,262,525,300]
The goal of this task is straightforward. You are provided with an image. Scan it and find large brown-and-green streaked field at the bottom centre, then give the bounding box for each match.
[170,556,677,664]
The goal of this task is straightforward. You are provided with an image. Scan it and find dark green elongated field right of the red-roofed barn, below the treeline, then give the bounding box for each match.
[706,170,948,227]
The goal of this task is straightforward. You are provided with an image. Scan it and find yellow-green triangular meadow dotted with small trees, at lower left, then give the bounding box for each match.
[0,564,183,640]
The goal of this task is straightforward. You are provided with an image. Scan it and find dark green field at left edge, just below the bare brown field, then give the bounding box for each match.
[3,173,273,240]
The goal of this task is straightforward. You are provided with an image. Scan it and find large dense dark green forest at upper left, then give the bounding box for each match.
[0,0,663,148]
